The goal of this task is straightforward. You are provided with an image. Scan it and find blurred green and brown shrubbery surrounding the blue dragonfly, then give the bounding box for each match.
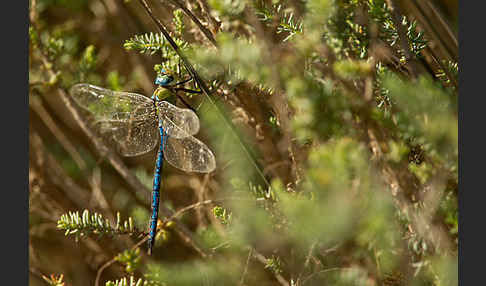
[29,0,458,285]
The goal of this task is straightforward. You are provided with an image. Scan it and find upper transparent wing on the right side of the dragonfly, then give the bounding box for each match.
[157,101,199,138]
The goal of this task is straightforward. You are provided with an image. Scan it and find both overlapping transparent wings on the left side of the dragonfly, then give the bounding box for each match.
[70,84,159,156]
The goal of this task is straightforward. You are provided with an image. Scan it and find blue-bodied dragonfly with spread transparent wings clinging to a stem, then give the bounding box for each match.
[70,69,216,255]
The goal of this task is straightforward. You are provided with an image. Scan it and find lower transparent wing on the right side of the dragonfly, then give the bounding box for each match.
[163,136,216,173]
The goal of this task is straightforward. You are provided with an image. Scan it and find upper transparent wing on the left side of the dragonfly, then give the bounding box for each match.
[70,83,155,121]
